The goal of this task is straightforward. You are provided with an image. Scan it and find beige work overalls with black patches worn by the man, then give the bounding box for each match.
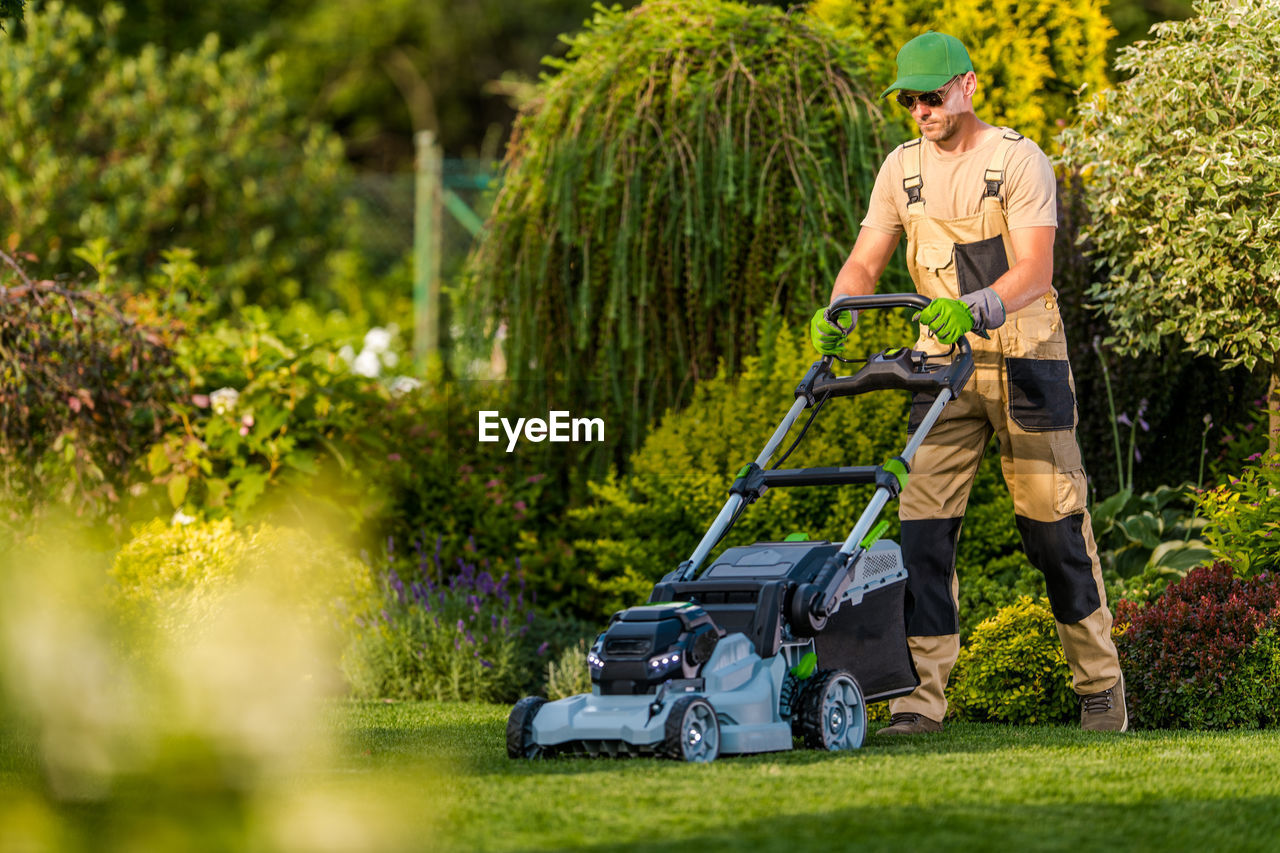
[891,129,1120,721]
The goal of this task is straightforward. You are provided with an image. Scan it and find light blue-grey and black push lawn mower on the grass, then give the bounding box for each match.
[507,293,974,762]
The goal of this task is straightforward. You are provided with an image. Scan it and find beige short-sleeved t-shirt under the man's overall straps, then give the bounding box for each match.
[863,128,1057,234]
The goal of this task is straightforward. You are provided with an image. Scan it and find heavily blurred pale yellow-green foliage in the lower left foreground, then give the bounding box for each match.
[0,523,450,850]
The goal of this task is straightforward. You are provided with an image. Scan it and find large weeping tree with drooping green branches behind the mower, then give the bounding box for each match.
[465,0,906,458]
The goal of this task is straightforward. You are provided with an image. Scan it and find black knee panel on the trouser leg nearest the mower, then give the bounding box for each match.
[901,519,963,637]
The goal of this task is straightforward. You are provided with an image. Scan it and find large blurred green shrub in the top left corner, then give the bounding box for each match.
[0,3,351,310]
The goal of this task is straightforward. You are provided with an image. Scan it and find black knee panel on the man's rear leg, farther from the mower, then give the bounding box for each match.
[1015,512,1102,625]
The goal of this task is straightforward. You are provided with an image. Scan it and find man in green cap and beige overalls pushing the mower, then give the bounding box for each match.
[812,32,1129,735]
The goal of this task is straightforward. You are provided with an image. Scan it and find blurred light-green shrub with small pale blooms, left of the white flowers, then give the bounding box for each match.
[143,307,398,535]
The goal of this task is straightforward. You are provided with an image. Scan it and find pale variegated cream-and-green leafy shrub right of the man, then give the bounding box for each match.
[1061,0,1280,451]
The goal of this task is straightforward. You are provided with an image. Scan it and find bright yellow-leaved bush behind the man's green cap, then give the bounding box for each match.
[809,0,1115,150]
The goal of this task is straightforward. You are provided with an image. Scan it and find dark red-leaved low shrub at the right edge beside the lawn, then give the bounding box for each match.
[1116,562,1280,729]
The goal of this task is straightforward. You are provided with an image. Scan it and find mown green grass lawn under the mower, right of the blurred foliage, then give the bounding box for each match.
[343,703,1280,852]
